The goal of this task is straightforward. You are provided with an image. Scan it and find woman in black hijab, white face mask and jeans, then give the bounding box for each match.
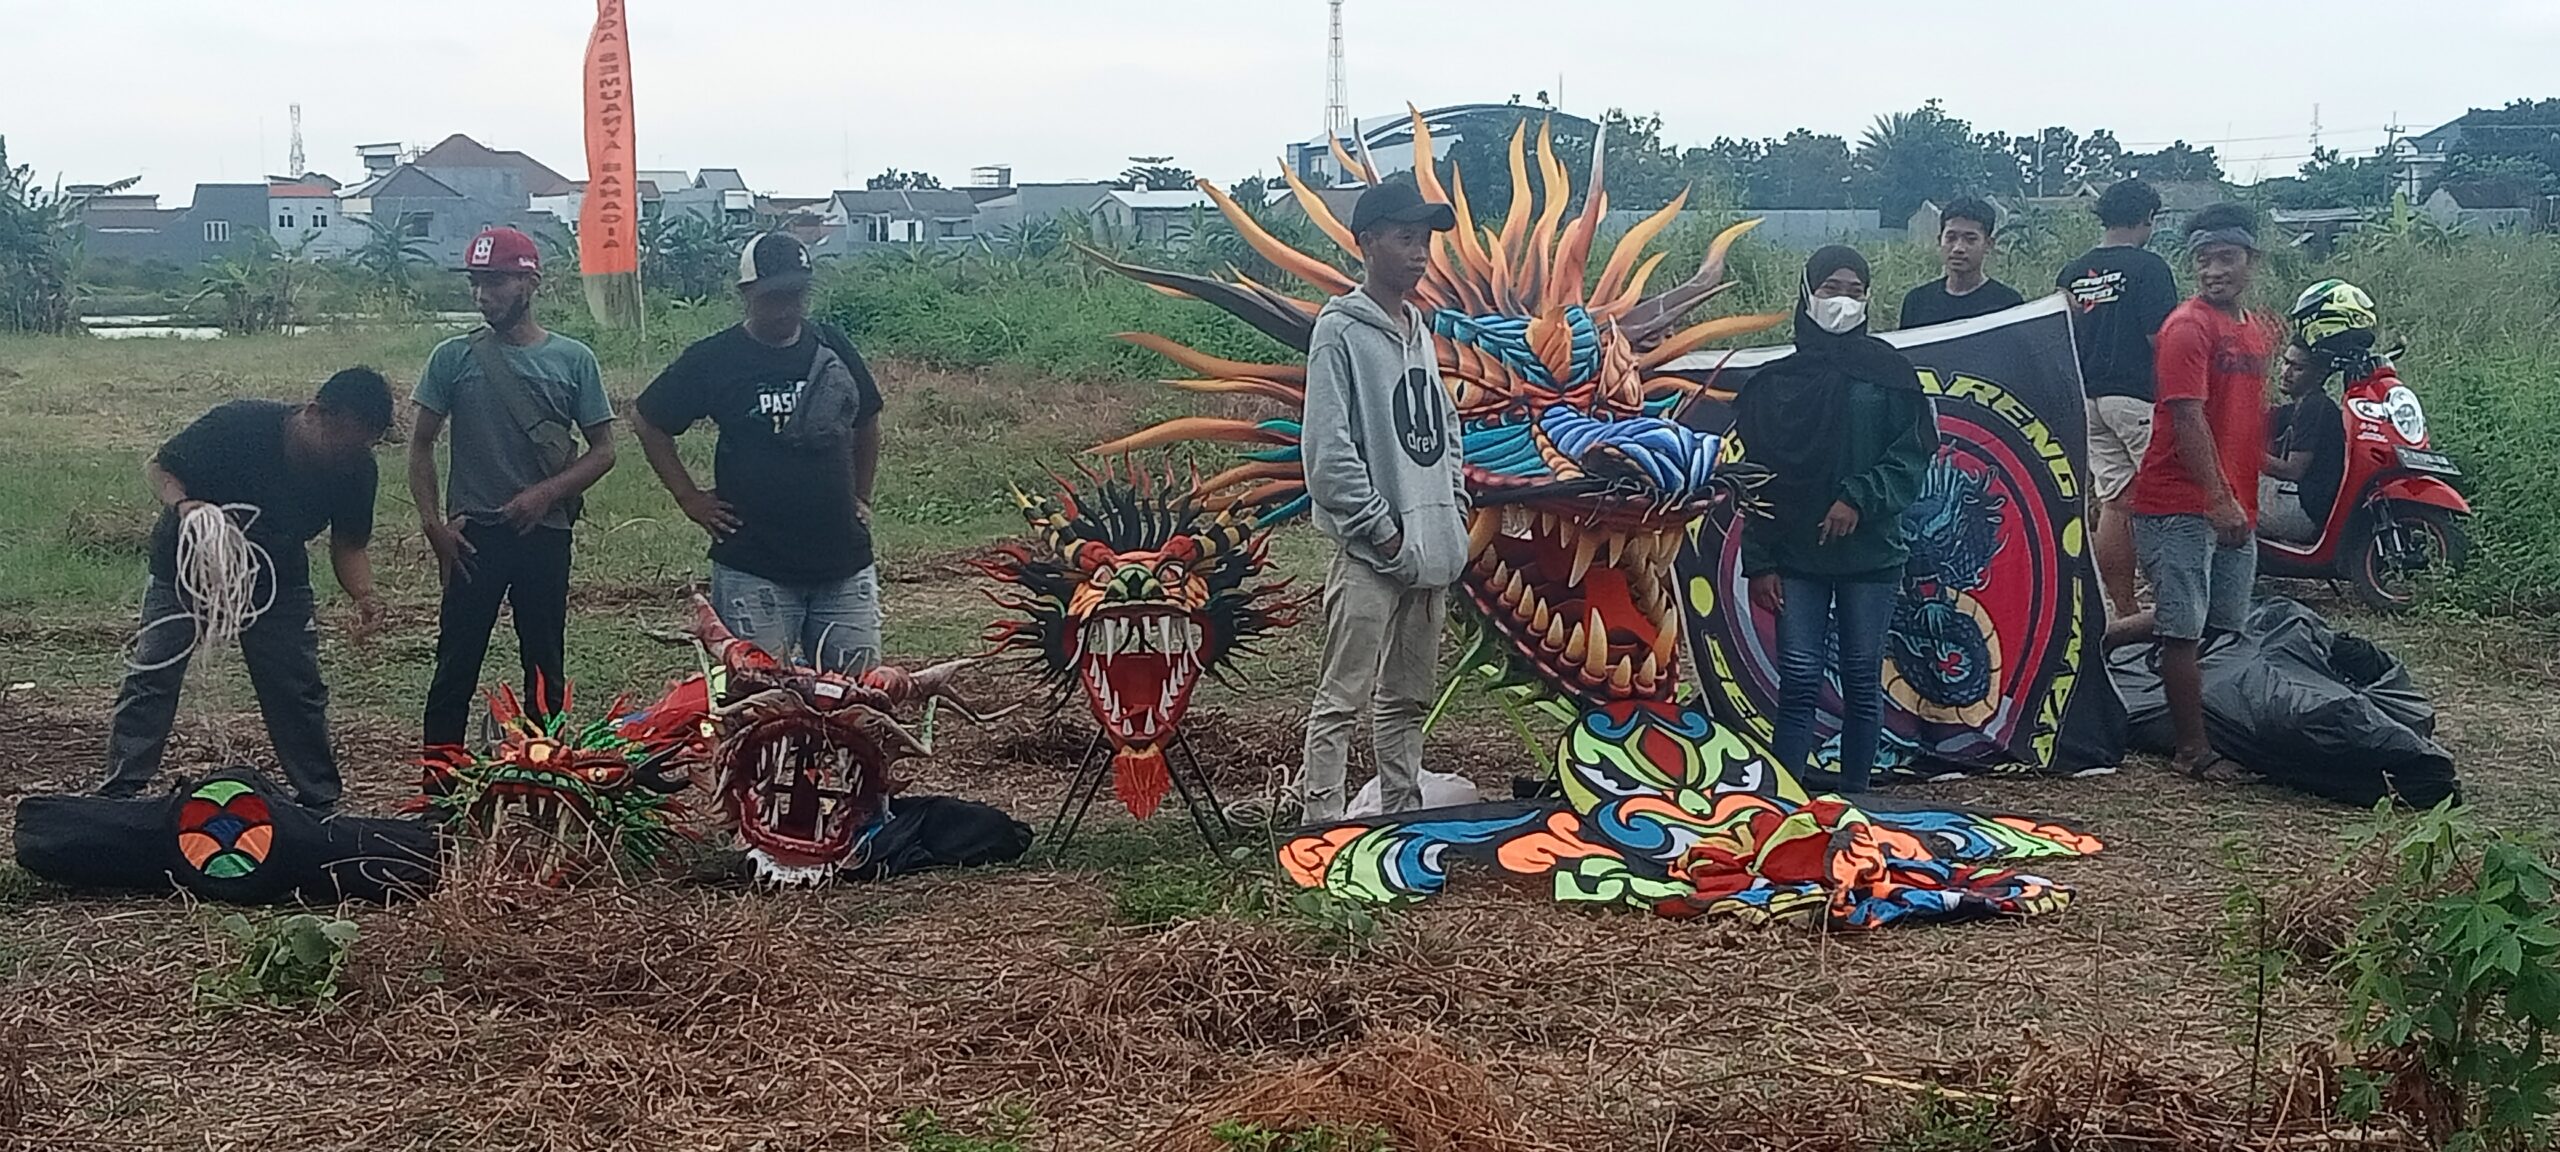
[1736,246,1938,791]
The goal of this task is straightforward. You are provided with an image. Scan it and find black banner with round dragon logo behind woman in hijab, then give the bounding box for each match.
[1677,297,2125,776]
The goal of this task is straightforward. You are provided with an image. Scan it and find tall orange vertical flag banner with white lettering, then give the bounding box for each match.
[579,0,643,328]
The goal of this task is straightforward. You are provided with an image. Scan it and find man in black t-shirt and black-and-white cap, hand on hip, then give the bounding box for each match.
[632,233,881,673]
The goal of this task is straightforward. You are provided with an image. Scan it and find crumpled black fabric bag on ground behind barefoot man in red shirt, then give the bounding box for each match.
[2107,596,2463,809]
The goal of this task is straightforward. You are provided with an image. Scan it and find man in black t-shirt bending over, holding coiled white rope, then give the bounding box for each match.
[97,369,392,812]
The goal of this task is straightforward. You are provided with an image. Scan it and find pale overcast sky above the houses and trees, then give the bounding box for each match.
[0,0,2560,202]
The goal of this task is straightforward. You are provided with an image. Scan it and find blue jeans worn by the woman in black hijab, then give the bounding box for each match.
[1772,576,1902,791]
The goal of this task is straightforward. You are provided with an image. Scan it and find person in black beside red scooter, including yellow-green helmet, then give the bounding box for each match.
[2258,279,2378,543]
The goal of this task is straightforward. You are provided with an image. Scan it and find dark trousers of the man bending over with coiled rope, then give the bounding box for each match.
[97,576,338,809]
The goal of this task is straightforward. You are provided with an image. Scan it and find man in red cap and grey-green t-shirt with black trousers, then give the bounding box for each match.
[410,228,614,748]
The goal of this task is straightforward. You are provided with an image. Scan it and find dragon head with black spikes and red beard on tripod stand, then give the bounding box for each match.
[980,466,1295,819]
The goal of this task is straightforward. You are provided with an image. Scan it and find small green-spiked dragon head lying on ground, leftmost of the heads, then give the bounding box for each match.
[417,686,691,883]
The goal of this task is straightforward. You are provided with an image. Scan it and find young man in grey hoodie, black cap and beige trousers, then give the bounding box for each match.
[1298,182,1467,824]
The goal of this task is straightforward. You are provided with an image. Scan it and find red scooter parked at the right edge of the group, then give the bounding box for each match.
[2258,358,2470,612]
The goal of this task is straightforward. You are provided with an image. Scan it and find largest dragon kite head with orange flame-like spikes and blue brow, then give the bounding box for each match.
[1096,113,1784,707]
